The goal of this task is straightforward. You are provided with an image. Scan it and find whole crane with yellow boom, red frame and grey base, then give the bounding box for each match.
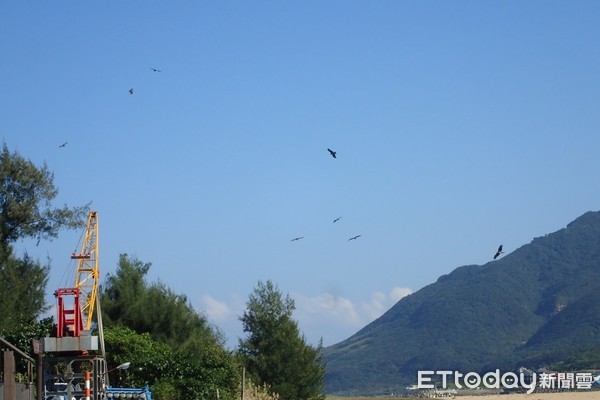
[38,211,151,400]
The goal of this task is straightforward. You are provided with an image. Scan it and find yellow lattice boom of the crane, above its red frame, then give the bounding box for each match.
[71,211,100,330]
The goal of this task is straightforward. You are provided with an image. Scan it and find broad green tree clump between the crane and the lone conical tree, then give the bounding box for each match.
[101,254,239,400]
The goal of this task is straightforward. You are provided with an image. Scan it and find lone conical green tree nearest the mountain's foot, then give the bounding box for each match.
[239,281,325,400]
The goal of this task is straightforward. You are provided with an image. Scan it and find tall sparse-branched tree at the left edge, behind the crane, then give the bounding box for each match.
[0,143,88,335]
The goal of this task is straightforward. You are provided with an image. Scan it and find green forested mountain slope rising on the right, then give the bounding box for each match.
[324,212,600,395]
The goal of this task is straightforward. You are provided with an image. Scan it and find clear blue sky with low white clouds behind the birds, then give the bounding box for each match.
[0,1,600,346]
